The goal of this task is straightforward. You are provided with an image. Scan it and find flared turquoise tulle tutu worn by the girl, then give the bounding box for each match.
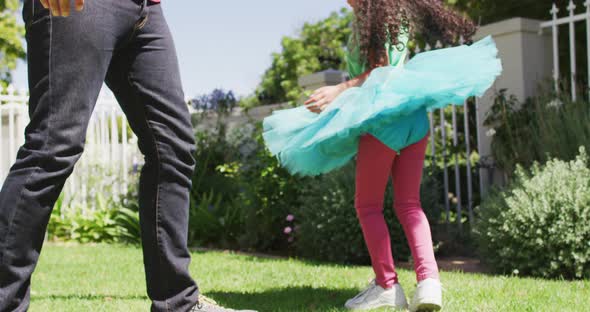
[263,37,502,175]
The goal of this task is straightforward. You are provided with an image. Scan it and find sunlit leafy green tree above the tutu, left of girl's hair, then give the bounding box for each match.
[256,9,352,104]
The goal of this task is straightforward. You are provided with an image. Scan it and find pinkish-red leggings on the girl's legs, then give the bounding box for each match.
[355,135,438,288]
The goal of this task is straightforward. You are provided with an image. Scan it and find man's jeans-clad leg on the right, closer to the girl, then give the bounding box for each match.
[107,5,198,312]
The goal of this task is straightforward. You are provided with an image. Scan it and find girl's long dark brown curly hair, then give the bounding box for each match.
[354,0,476,67]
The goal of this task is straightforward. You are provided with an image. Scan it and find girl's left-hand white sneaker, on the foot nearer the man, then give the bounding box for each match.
[344,281,408,310]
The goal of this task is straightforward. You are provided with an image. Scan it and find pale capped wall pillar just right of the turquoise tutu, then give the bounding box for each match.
[475,18,553,195]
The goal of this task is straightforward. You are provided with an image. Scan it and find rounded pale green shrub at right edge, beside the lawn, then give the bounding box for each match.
[477,148,590,278]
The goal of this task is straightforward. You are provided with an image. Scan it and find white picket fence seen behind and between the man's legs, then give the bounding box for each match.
[0,87,142,211]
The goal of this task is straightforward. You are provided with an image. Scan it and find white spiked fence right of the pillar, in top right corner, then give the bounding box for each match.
[540,0,590,100]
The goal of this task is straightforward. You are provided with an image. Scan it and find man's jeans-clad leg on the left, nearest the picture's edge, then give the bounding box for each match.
[0,0,123,312]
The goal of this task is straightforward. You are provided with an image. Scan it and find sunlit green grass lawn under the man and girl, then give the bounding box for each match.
[31,244,590,312]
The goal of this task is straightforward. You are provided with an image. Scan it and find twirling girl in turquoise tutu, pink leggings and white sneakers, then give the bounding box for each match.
[264,0,502,311]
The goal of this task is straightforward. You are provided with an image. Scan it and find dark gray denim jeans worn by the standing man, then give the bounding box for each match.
[0,0,198,312]
